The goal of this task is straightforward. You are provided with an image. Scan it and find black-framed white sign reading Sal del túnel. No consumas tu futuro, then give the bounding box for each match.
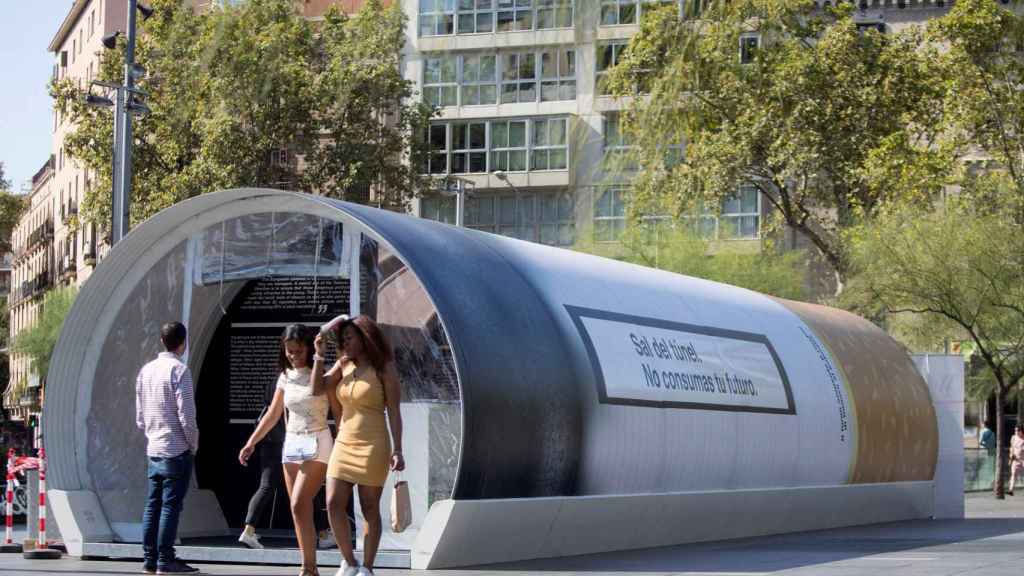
[565,305,797,414]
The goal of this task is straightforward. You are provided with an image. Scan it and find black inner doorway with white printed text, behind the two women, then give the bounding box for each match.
[196,277,356,534]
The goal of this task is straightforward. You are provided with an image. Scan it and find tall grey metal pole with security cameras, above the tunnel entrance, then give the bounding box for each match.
[85,0,153,246]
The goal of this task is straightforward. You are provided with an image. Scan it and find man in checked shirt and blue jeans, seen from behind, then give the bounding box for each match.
[135,322,199,574]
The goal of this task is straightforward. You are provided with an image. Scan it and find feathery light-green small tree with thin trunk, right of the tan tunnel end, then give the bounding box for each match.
[843,189,1024,498]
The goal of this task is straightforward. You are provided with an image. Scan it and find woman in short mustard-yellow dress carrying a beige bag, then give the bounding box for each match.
[312,316,406,576]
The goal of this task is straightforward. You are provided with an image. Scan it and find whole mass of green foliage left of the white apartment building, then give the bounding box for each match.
[51,0,429,228]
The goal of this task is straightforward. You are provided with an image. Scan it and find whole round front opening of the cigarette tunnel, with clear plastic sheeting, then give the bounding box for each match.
[71,208,462,550]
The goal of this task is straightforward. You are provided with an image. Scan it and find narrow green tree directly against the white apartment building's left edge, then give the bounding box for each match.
[304,0,434,209]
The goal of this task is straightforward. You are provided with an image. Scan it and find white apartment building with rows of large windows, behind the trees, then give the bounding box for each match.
[402,0,947,250]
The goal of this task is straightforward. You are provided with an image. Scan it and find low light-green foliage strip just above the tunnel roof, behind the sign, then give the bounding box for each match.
[574,223,804,299]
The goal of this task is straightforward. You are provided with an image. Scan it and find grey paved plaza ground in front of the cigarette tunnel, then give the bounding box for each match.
[0,493,1024,576]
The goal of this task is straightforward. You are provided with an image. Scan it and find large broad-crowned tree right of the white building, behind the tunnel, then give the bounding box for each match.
[608,0,955,291]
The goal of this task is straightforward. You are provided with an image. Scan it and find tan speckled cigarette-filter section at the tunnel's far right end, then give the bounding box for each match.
[777,299,939,484]
